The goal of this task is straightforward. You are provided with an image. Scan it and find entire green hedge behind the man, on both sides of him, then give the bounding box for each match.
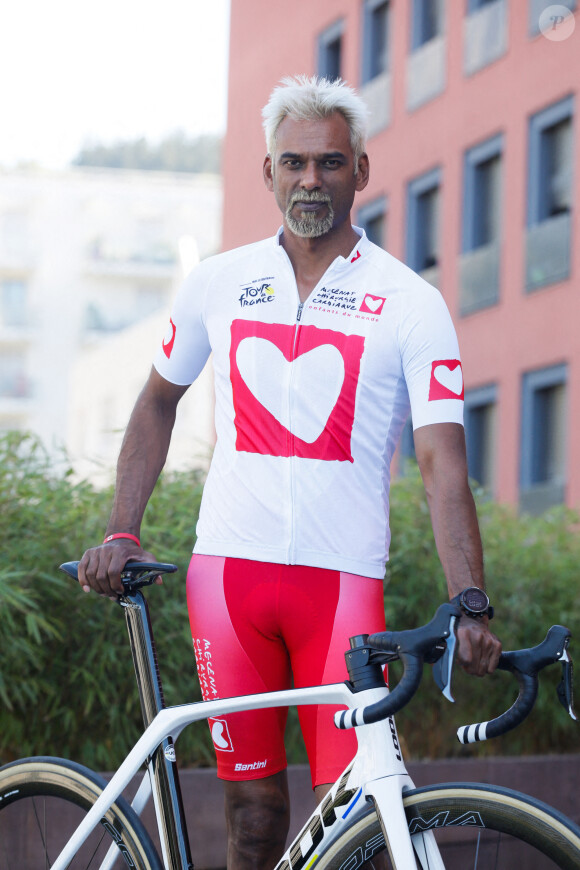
[0,433,580,770]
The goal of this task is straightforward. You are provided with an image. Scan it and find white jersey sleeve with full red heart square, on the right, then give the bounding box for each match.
[399,278,464,429]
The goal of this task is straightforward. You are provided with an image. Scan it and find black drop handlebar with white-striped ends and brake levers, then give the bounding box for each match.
[334,604,576,743]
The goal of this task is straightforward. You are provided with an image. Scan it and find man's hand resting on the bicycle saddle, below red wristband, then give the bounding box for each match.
[78,539,162,601]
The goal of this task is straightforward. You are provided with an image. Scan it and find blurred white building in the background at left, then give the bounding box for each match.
[0,168,222,478]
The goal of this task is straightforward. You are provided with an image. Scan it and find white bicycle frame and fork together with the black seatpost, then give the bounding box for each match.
[53,591,444,870]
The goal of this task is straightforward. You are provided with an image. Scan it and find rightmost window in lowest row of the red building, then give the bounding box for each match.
[520,365,567,513]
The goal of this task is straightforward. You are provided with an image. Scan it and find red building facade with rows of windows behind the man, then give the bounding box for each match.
[223,0,580,513]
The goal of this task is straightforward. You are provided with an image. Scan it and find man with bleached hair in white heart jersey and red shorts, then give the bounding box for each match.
[79,77,500,868]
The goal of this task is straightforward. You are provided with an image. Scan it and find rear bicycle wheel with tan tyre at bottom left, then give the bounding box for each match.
[0,756,163,870]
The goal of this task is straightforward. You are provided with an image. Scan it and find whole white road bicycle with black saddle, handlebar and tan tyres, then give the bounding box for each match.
[0,562,580,870]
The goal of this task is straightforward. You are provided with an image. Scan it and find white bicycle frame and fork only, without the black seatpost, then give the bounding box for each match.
[52,683,445,870]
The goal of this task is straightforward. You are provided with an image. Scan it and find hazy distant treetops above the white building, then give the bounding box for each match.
[72,130,222,174]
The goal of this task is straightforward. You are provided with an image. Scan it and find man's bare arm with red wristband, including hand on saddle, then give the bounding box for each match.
[78,369,187,597]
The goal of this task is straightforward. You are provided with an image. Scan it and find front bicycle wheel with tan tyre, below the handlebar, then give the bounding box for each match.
[314,783,580,870]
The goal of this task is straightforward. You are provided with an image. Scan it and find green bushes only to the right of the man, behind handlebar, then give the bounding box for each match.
[385,468,580,758]
